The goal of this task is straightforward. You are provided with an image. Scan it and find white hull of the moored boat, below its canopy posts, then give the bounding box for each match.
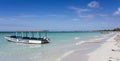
[5,36,49,44]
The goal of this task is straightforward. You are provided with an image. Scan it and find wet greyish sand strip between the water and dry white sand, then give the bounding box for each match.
[59,34,117,61]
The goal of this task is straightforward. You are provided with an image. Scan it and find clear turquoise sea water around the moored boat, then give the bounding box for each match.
[0,32,109,61]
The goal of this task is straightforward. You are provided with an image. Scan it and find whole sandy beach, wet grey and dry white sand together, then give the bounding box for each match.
[56,33,120,61]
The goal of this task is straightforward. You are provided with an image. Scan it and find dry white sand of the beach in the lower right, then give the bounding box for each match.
[88,34,120,61]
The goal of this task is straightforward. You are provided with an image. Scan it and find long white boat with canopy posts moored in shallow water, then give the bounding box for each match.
[5,32,49,44]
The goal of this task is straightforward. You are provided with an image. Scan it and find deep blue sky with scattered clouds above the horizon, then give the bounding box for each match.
[0,0,120,31]
